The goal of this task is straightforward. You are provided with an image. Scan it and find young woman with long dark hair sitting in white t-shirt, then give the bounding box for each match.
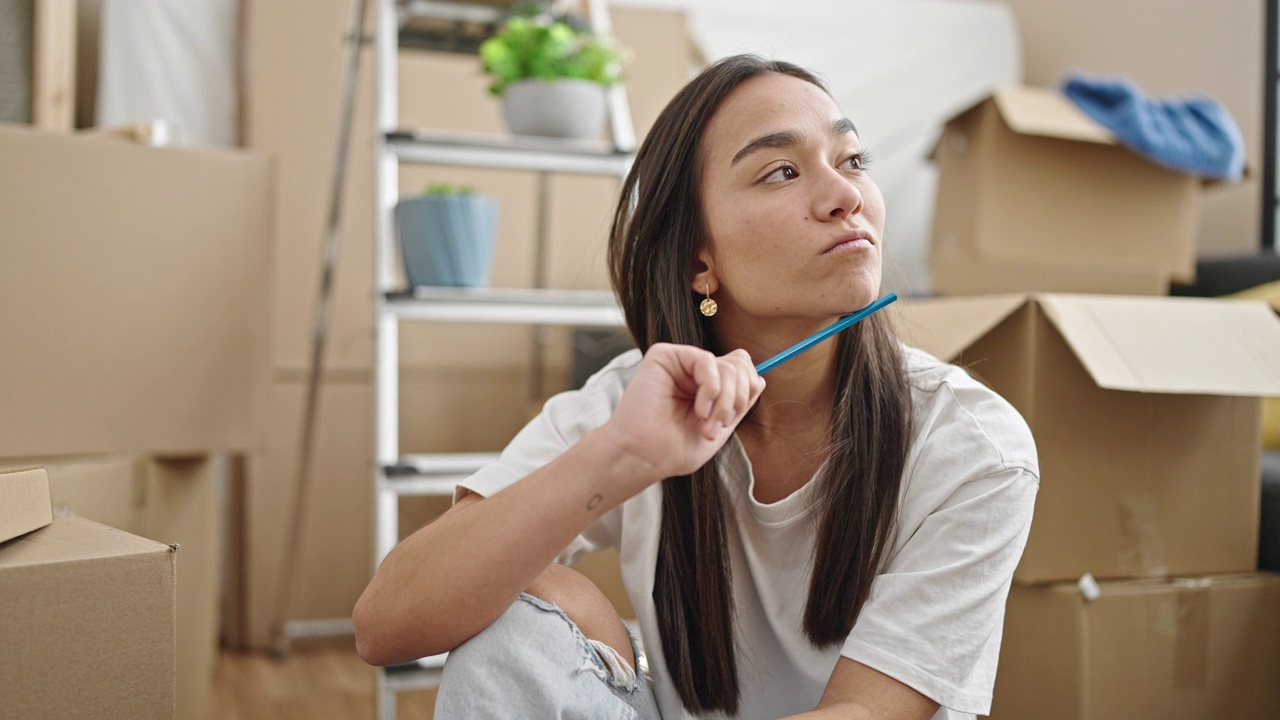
[355,56,1038,720]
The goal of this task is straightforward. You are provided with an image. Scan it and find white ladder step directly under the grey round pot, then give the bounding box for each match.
[387,129,632,178]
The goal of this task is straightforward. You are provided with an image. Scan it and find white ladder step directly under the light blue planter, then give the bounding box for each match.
[385,287,623,327]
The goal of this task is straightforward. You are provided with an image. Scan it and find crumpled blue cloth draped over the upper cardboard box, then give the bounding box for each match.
[1062,74,1244,182]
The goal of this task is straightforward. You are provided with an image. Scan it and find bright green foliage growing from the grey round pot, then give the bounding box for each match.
[480,13,626,95]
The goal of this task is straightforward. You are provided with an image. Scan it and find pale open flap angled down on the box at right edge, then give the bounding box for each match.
[1037,295,1280,397]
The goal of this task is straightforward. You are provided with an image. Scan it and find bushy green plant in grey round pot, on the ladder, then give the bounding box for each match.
[480,7,625,138]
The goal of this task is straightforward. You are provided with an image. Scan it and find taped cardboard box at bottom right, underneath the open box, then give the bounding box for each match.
[991,574,1280,720]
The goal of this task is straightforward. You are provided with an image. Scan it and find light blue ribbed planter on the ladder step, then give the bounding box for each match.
[396,195,498,287]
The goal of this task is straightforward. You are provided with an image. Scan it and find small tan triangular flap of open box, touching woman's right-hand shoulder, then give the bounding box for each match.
[890,295,1027,360]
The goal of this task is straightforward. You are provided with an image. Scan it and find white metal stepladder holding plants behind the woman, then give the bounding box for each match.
[372,0,635,720]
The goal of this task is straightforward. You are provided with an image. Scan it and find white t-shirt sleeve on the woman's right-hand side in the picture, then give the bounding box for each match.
[841,376,1039,715]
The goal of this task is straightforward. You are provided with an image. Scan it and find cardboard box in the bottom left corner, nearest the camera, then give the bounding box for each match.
[0,516,177,719]
